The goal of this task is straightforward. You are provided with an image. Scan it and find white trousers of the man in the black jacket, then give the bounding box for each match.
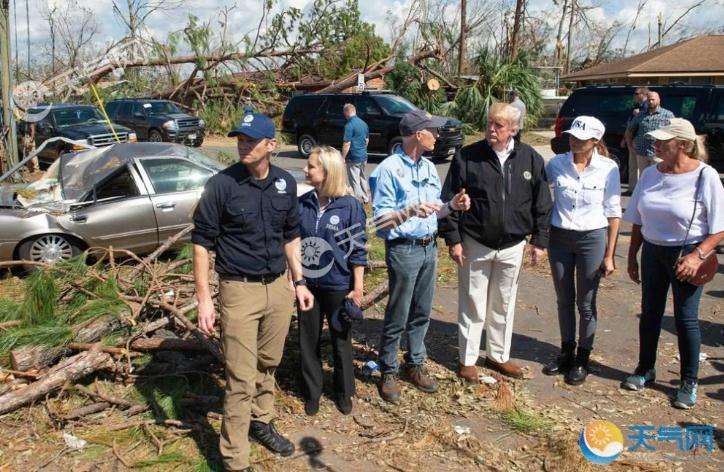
[458,237,525,366]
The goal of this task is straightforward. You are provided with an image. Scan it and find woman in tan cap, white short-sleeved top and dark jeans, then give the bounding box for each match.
[621,118,724,409]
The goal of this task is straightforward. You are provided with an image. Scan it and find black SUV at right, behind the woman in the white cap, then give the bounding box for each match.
[551,85,724,178]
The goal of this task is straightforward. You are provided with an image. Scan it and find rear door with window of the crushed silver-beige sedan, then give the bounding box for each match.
[138,157,214,242]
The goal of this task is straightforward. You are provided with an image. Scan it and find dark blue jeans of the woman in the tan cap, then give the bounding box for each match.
[638,241,703,382]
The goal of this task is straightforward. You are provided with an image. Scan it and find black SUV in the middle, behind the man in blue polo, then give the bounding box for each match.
[281,91,463,158]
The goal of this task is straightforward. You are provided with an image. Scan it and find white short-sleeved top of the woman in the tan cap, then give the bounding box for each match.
[623,163,724,246]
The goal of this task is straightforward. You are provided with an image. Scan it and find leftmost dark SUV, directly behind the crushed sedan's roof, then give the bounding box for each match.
[30,103,136,162]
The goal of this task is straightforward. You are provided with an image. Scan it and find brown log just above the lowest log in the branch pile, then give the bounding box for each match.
[10,315,121,372]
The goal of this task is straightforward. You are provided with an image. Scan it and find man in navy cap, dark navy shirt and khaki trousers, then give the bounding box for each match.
[191,113,313,471]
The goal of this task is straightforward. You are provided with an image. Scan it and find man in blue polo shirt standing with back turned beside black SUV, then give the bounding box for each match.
[342,103,370,203]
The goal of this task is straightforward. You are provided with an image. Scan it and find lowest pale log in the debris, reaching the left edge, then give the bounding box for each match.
[0,350,112,415]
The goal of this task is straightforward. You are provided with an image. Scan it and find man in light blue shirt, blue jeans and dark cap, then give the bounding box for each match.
[370,110,470,403]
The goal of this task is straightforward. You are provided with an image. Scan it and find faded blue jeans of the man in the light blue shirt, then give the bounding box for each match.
[379,241,437,374]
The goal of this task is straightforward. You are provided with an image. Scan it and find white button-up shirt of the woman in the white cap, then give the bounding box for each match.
[546,149,621,231]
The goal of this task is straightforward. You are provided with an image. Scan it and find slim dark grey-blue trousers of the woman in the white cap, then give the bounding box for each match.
[548,226,608,351]
